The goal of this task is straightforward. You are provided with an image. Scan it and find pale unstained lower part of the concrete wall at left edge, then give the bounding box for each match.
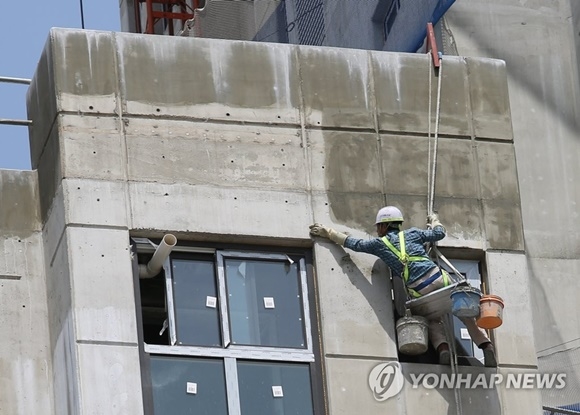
[0,234,53,414]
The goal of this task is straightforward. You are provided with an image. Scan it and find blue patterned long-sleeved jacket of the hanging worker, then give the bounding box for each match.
[344,226,445,285]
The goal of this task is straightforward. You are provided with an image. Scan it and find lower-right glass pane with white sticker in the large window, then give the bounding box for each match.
[238,362,314,415]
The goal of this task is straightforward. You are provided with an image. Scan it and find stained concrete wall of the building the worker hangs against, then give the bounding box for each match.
[20,29,540,415]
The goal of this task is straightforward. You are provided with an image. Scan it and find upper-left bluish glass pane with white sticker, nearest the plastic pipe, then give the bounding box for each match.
[172,259,221,346]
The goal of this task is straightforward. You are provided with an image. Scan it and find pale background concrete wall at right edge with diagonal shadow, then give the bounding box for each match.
[446,0,580,405]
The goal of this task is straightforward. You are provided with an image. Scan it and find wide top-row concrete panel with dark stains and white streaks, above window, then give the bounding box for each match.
[115,34,300,124]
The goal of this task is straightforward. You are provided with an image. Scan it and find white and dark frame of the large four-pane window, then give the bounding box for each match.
[131,237,326,415]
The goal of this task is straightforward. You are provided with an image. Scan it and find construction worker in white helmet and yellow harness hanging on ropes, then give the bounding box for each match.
[310,206,497,367]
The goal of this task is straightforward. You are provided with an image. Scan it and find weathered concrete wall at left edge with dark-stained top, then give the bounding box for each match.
[0,170,53,415]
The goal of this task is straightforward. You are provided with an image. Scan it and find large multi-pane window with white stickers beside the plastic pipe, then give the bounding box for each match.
[133,238,323,415]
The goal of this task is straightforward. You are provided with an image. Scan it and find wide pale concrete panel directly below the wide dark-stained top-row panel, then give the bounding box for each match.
[126,119,308,189]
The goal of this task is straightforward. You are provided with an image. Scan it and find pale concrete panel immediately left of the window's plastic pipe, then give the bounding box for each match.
[66,227,137,344]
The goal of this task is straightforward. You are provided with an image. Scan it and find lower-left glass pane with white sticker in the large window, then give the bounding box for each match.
[151,356,228,415]
